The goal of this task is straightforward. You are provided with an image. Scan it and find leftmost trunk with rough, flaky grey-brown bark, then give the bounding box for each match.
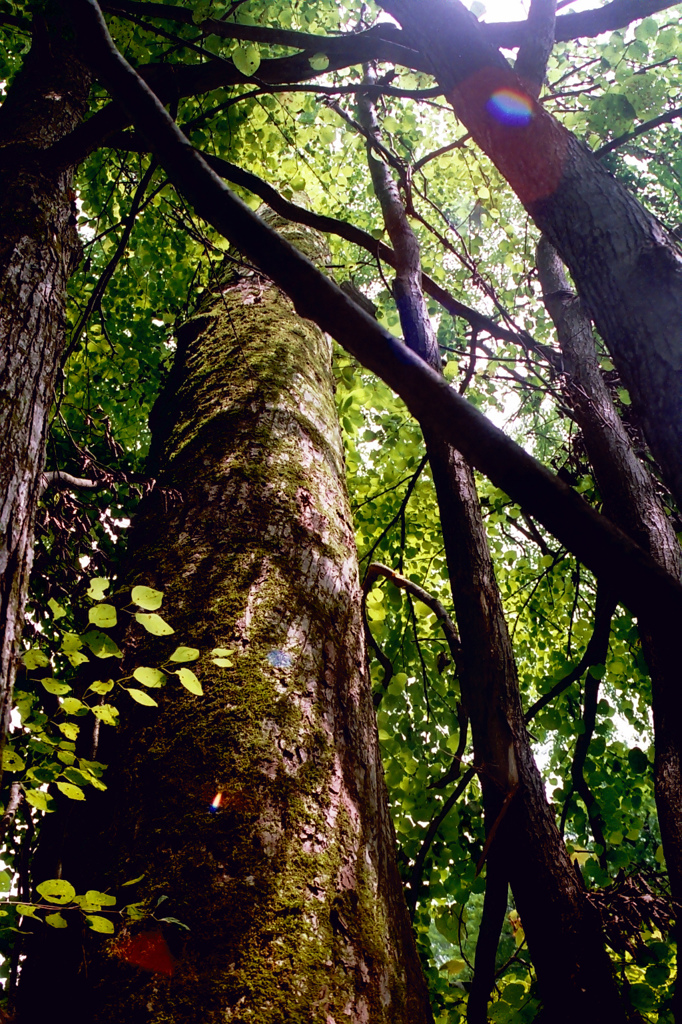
[0,12,90,745]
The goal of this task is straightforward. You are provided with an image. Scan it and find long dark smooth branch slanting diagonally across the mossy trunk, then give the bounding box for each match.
[69,0,682,629]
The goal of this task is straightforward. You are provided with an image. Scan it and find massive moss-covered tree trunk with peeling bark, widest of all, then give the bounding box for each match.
[18,216,432,1024]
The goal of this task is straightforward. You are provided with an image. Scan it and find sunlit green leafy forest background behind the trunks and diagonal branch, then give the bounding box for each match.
[0,0,682,1024]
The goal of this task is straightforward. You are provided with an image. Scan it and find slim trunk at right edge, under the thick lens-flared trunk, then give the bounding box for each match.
[538,239,682,1017]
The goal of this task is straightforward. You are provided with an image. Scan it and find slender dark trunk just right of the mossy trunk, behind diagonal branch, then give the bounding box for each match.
[358,88,636,1024]
